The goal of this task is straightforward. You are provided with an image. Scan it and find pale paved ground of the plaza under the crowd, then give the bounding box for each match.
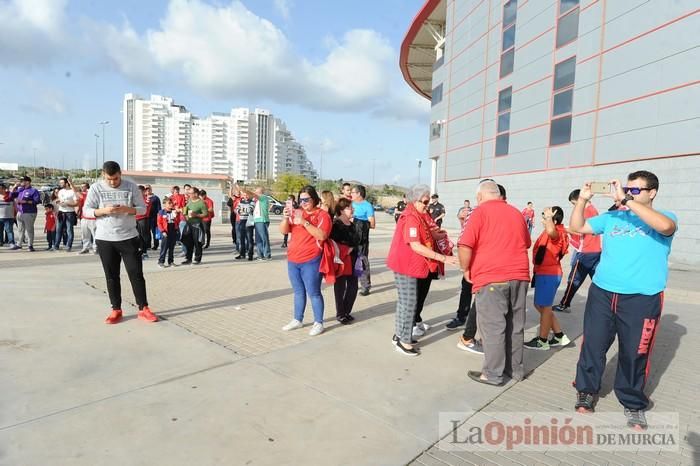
[0,214,700,465]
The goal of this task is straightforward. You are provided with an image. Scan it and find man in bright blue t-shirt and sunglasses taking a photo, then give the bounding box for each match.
[570,171,678,430]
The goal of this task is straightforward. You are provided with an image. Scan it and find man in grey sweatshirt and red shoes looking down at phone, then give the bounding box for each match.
[83,161,158,324]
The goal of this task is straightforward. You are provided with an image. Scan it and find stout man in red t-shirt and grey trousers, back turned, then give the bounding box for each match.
[458,180,531,386]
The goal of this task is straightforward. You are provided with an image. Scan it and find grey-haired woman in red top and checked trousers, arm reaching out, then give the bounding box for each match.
[386,185,457,356]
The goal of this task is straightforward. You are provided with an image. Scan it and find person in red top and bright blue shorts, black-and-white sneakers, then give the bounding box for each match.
[525,206,571,351]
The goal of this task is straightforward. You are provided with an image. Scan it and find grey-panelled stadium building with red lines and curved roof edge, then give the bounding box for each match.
[400,0,700,266]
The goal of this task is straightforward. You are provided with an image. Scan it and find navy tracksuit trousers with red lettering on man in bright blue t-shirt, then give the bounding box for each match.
[576,284,664,409]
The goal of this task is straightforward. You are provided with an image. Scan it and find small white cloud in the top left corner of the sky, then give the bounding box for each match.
[0,0,68,66]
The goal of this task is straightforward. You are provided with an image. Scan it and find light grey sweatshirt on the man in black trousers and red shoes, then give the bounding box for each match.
[83,178,146,241]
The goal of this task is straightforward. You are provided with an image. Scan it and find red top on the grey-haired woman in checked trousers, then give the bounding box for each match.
[386,206,437,278]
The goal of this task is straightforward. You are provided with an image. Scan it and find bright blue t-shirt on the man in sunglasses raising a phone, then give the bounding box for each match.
[587,210,678,296]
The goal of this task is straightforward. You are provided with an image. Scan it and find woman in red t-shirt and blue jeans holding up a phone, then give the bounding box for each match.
[280,186,332,336]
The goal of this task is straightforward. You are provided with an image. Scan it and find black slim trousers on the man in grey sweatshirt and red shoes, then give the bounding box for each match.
[96,236,148,310]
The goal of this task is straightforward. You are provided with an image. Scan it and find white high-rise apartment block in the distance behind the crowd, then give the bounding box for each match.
[123,94,317,182]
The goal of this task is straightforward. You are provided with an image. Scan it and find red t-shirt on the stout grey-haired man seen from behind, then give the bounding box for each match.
[458,200,531,293]
